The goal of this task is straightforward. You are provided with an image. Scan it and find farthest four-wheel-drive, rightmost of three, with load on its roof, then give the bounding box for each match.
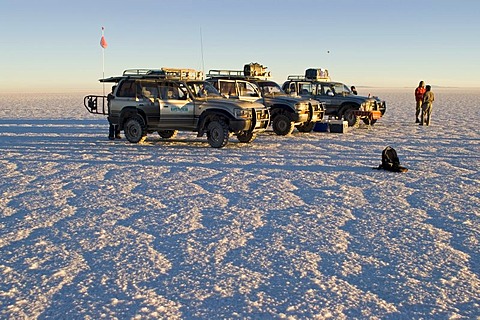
[282,68,386,126]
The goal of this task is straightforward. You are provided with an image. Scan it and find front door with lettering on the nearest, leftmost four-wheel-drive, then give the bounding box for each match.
[159,81,195,129]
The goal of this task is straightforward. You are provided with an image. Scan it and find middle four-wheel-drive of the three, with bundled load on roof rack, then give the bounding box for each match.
[206,63,325,135]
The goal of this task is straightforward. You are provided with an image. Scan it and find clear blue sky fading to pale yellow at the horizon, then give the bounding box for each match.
[0,0,480,92]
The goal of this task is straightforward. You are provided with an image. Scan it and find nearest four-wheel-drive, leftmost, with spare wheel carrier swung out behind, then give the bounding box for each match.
[84,68,270,148]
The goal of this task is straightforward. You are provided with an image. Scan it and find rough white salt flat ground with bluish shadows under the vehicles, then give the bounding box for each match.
[0,89,480,319]
